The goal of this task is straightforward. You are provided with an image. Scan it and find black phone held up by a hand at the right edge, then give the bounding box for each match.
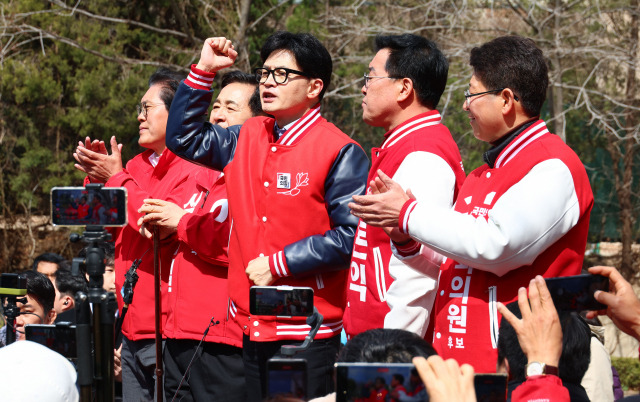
[545,274,609,311]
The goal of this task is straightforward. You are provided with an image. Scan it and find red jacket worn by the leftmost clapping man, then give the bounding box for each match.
[105,150,197,341]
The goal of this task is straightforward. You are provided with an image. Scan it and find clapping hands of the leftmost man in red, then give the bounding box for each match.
[73,136,122,183]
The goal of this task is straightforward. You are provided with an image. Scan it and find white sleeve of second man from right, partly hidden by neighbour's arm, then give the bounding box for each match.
[384,151,456,336]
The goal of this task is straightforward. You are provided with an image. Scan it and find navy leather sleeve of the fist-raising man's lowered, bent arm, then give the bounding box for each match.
[284,144,369,276]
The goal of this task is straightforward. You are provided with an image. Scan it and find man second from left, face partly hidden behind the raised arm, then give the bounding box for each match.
[139,71,262,401]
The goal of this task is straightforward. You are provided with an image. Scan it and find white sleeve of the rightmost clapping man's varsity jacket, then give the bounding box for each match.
[409,159,580,276]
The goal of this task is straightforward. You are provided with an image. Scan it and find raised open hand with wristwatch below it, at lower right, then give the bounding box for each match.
[498,275,562,367]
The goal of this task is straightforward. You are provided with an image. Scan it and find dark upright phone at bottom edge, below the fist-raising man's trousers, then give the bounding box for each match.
[267,358,307,401]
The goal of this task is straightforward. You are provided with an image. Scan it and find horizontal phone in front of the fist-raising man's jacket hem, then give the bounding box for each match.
[249,286,313,317]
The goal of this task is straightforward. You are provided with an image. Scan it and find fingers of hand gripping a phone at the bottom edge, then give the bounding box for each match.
[413,355,476,402]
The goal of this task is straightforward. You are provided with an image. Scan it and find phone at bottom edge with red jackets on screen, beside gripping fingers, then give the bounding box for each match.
[334,363,420,402]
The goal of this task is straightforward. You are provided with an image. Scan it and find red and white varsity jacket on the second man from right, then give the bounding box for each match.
[344,110,465,338]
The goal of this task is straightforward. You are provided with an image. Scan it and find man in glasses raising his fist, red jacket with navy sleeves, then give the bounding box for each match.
[162,31,368,401]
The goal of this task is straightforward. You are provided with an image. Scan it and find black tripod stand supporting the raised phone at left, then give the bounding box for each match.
[71,226,116,401]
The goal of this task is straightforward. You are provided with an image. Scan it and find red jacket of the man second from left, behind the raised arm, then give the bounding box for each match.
[164,168,242,347]
